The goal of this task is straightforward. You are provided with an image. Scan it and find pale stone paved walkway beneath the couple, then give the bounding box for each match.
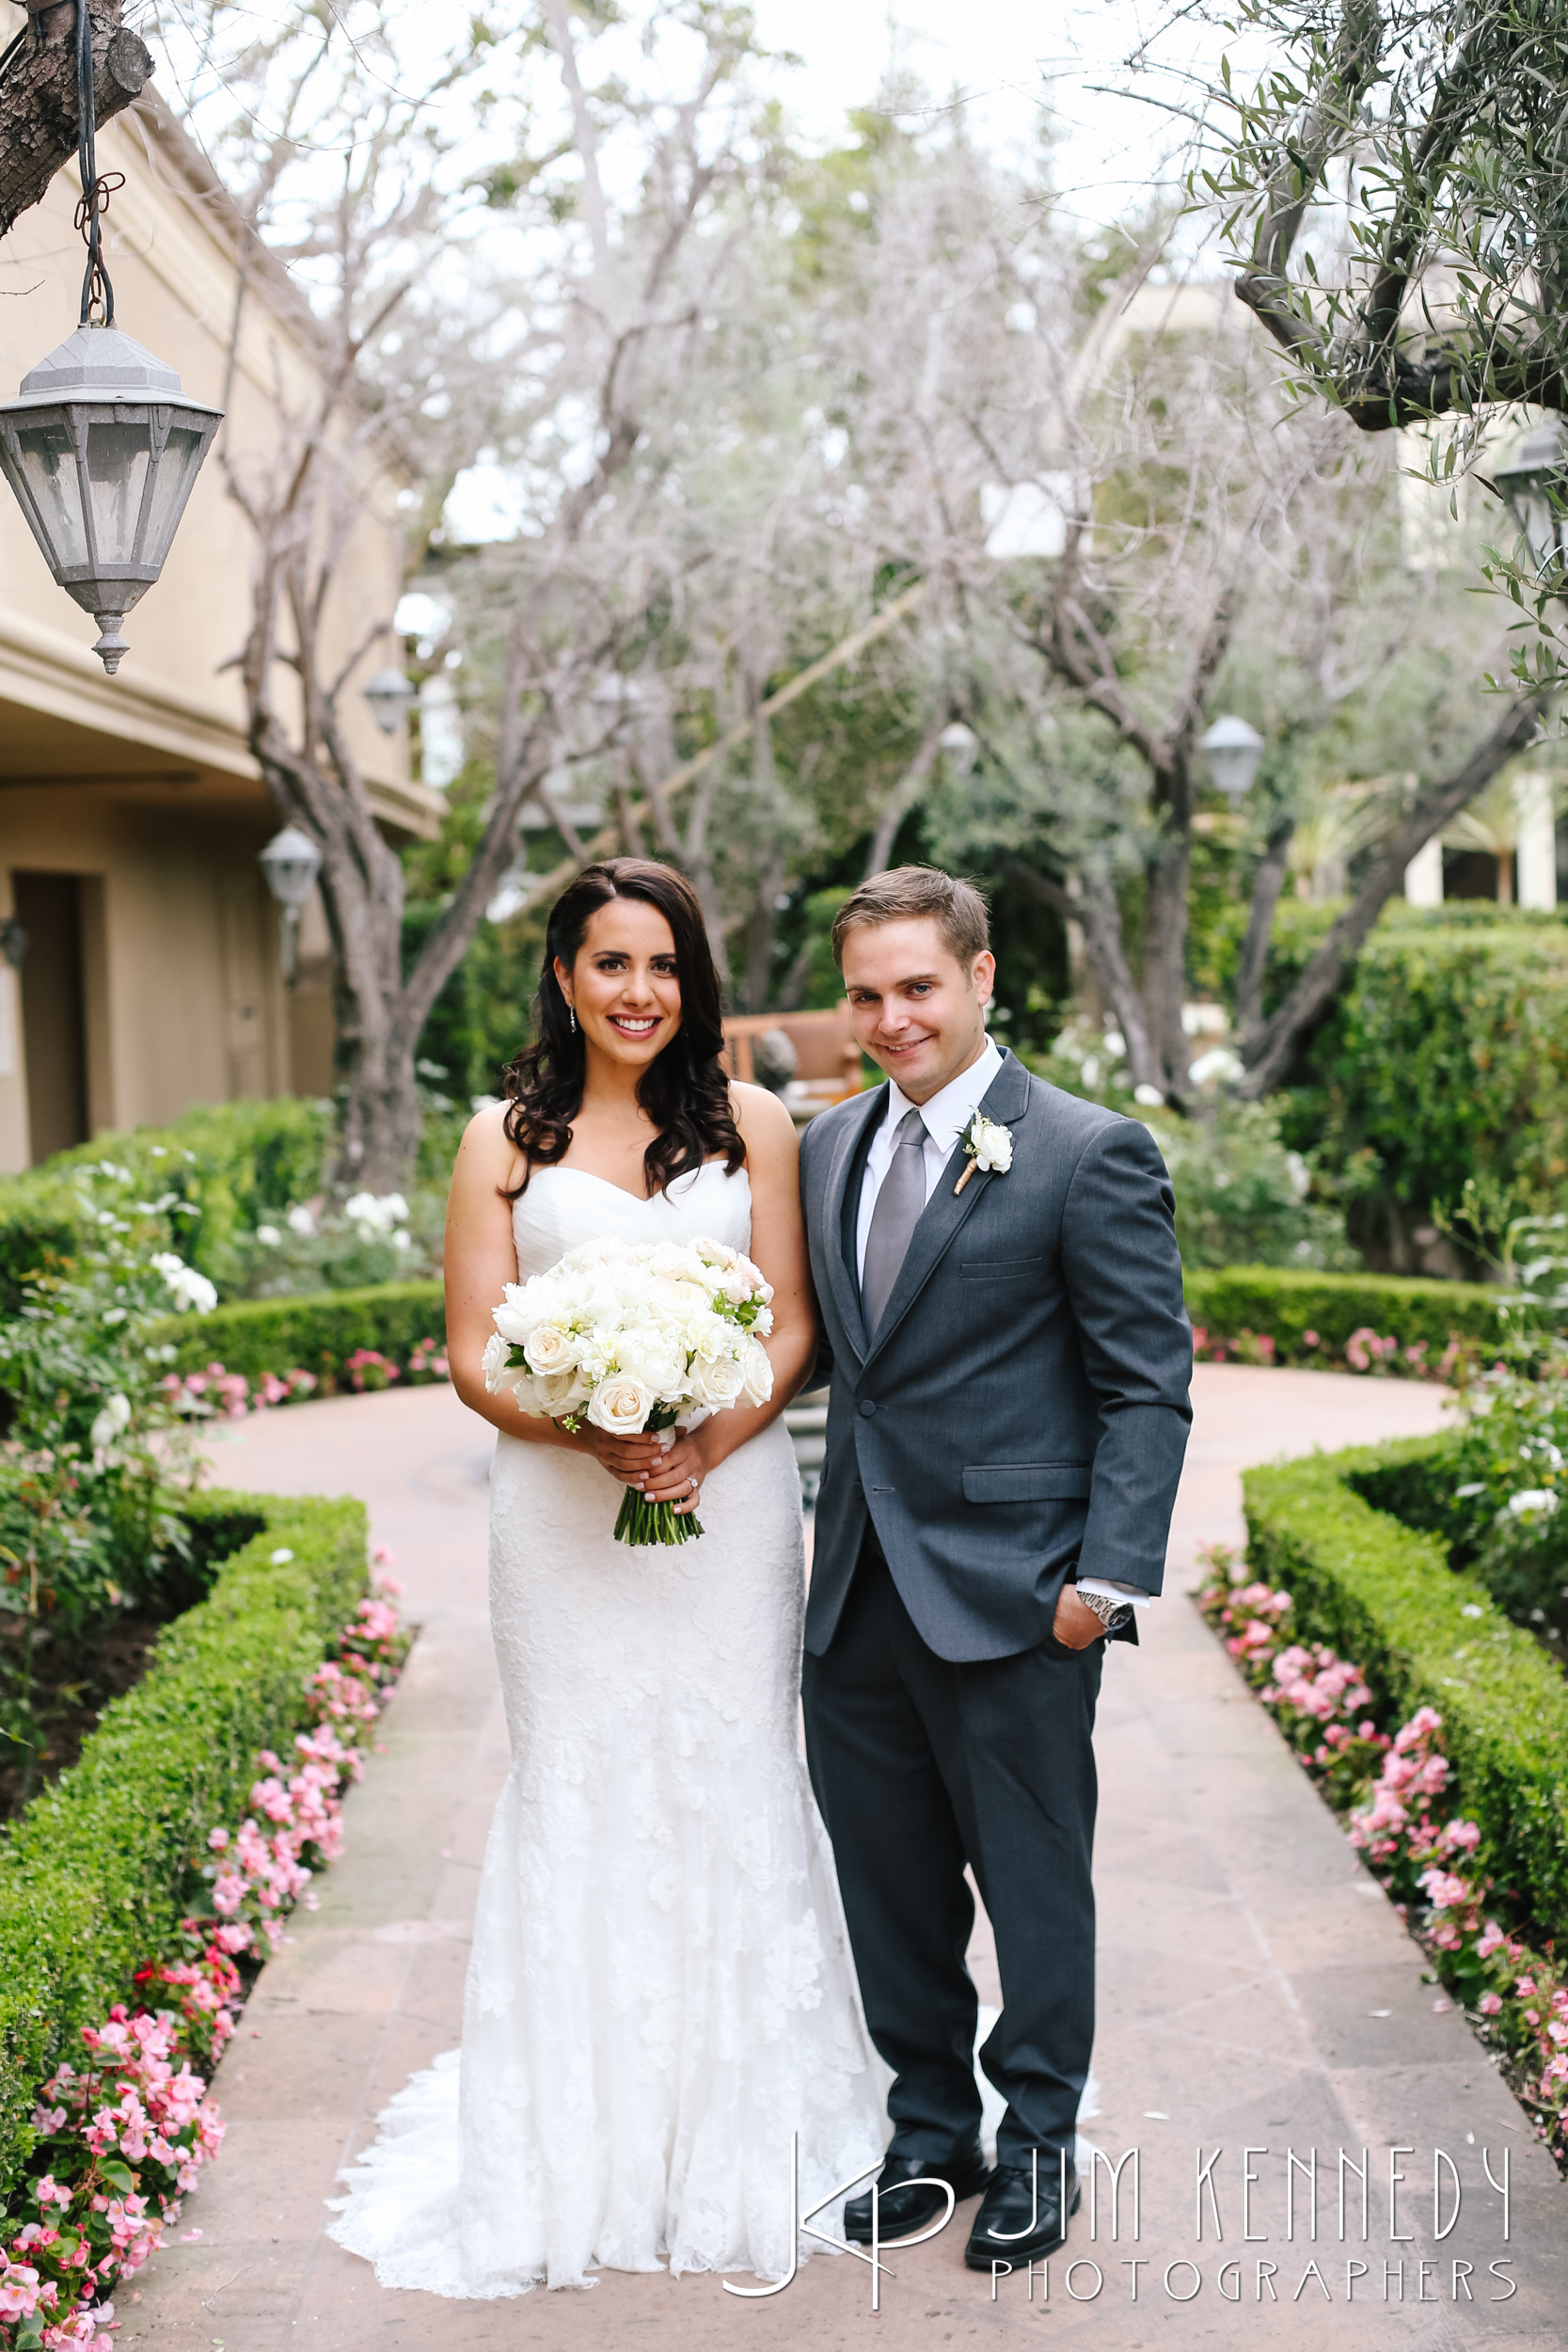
[119,1367,1568,2352]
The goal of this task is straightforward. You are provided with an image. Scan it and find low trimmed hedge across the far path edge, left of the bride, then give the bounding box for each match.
[157,1282,447,1381]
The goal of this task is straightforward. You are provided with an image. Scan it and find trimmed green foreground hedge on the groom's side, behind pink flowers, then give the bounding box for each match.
[1242,1438,1568,1936]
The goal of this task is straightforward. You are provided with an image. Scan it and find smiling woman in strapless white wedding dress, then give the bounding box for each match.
[331,859,886,2296]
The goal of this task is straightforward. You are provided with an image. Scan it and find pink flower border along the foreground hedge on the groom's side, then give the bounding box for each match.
[1199,1546,1568,2169]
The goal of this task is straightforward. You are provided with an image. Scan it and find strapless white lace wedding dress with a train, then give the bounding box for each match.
[331,1162,886,2296]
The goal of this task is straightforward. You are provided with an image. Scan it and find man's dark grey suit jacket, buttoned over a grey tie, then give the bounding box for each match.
[801,1054,1192,1661]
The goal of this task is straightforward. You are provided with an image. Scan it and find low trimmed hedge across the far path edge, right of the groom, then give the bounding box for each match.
[1182,1265,1530,1364]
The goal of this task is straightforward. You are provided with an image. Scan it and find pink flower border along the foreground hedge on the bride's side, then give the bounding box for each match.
[0,1546,402,2352]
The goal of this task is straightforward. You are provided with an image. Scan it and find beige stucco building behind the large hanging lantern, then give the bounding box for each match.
[0,102,439,1169]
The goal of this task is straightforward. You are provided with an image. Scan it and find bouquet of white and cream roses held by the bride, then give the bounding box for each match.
[484,1235,773,1543]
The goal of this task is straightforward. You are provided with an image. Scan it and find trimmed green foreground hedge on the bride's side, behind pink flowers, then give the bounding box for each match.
[0,1491,367,2195]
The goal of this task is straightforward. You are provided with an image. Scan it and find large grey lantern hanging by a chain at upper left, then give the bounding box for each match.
[0,0,223,677]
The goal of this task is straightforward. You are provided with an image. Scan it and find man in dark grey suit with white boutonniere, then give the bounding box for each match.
[801,866,1192,2270]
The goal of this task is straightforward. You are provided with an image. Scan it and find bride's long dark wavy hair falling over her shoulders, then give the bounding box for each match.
[505,859,745,1200]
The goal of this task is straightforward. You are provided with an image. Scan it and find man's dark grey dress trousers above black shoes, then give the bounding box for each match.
[804,1536,1105,2178]
